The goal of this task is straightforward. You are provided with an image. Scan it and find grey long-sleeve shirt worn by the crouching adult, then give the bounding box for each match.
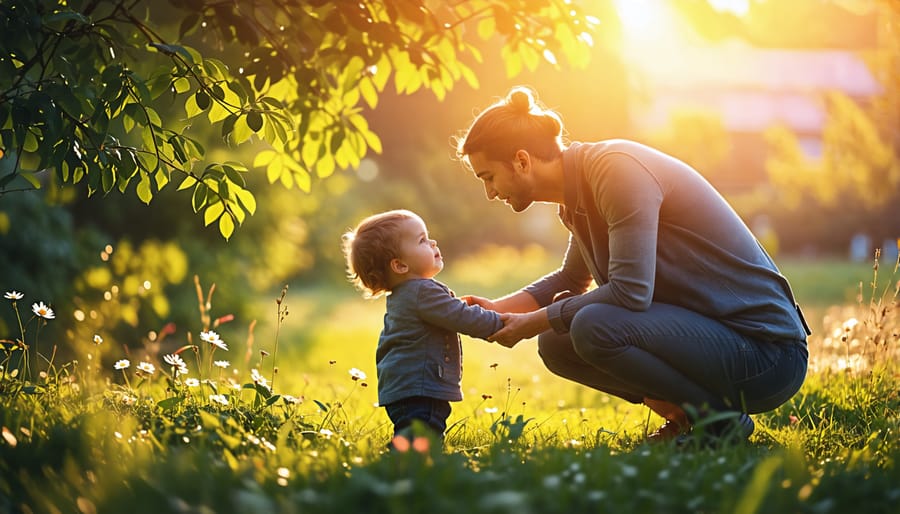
[525,140,808,341]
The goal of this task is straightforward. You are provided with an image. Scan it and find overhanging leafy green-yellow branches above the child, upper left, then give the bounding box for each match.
[0,0,598,238]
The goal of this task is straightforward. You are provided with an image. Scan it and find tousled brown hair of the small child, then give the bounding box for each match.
[341,209,419,298]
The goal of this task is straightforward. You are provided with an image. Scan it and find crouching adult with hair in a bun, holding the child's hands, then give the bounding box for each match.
[456,87,809,442]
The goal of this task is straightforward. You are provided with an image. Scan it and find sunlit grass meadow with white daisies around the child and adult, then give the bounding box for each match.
[0,248,900,514]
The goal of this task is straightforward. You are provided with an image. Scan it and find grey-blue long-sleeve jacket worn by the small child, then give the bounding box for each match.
[375,279,503,405]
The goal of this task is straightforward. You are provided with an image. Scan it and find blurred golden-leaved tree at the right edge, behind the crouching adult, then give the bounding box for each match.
[767,0,900,252]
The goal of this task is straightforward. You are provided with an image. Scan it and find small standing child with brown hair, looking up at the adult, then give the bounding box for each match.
[343,210,503,444]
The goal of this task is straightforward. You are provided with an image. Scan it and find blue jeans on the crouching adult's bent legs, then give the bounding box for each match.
[538,303,808,414]
